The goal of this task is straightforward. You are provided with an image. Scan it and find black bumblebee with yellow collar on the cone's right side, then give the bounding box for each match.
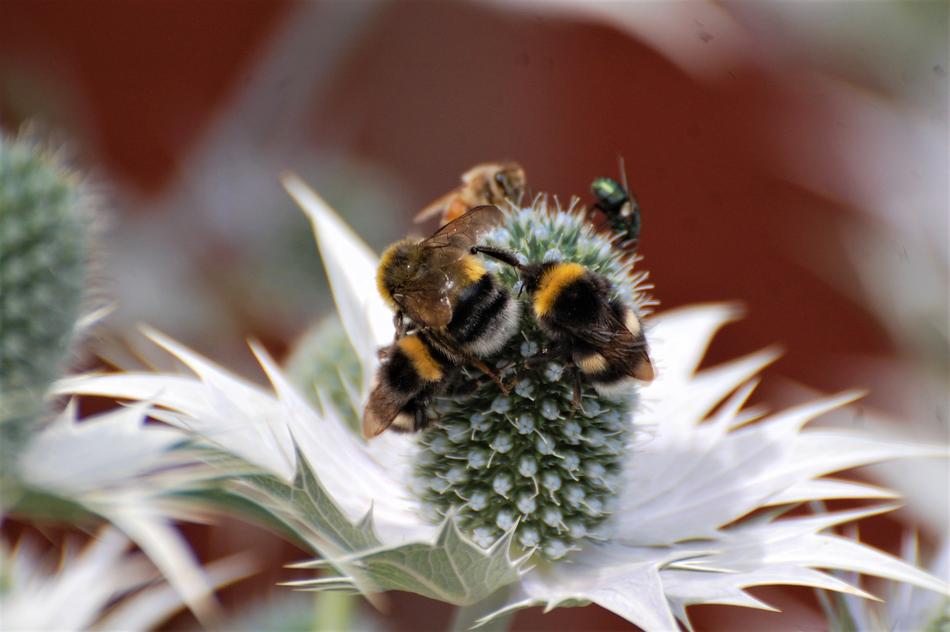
[476,247,654,395]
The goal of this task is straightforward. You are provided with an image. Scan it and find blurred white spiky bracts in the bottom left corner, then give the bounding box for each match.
[0,529,250,631]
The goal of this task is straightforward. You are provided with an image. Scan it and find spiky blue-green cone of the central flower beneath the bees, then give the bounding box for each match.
[412,202,646,559]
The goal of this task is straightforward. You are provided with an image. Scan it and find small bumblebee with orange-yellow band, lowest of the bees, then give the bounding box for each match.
[363,334,451,439]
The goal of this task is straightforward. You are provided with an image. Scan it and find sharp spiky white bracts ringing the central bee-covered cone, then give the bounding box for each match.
[55,178,947,629]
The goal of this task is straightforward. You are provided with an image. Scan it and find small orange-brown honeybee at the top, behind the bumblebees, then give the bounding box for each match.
[415,161,526,224]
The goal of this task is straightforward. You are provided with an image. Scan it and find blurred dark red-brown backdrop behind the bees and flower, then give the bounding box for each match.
[0,0,946,629]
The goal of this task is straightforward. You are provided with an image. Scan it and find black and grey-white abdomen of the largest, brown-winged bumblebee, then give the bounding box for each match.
[446,272,520,358]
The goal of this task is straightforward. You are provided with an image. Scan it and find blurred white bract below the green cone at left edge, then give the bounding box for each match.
[16,404,235,620]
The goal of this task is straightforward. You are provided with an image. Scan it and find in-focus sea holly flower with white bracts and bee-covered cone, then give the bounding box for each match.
[59,177,947,630]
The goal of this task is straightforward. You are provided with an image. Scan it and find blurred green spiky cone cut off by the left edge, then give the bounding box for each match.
[0,133,93,444]
